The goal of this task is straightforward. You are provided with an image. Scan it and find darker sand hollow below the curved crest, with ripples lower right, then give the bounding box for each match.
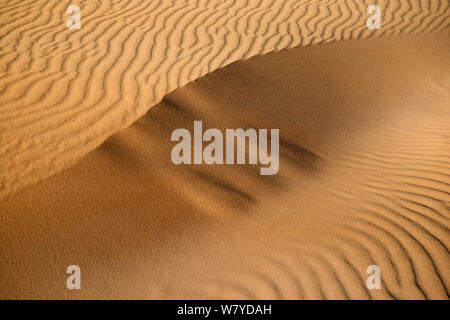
[0,34,450,299]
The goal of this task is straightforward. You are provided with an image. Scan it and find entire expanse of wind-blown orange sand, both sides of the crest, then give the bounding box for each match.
[0,0,450,299]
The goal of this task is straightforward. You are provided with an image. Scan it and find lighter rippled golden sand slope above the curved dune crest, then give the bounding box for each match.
[0,0,450,197]
